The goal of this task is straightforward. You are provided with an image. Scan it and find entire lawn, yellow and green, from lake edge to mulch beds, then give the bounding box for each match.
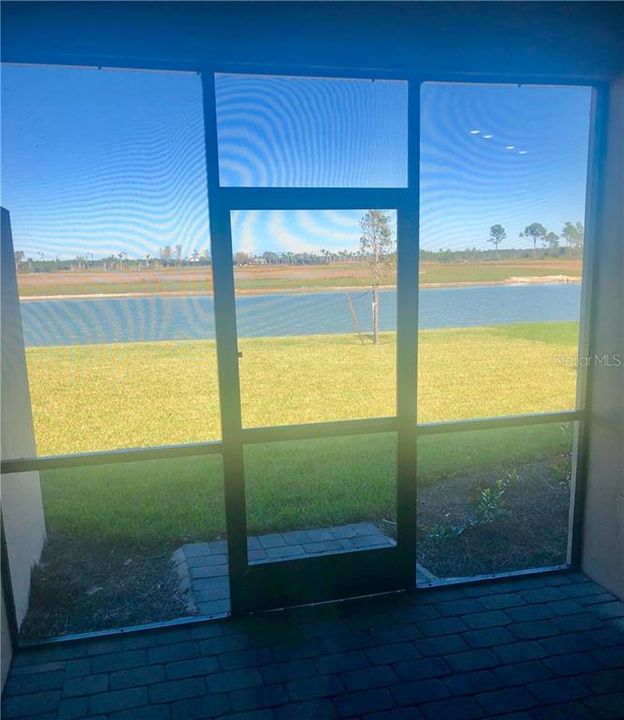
[27,323,578,547]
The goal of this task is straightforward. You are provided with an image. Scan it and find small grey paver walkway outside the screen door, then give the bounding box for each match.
[173,522,432,617]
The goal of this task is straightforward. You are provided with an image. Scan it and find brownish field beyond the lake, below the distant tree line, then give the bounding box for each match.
[18,258,581,297]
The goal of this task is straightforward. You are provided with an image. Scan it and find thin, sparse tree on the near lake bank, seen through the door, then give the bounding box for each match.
[360,210,396,344]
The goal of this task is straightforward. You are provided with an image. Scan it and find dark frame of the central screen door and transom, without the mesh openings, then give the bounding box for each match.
[202,66,420,614]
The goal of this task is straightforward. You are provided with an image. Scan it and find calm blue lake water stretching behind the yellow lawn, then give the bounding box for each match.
[21,284,581,347]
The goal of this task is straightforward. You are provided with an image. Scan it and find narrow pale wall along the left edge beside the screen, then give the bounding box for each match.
[0,208,45,688]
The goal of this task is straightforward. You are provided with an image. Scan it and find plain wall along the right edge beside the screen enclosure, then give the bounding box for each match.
[582,76,624,598]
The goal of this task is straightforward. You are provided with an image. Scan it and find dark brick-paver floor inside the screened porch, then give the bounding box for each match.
[2,573,624,720]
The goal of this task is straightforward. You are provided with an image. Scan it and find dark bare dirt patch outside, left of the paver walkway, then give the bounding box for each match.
[22,533,188,637]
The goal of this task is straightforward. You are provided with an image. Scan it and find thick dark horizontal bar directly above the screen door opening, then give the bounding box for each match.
[213,185,409,212]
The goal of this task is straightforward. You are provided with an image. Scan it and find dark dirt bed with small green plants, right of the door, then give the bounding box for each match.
[417,458,570,578]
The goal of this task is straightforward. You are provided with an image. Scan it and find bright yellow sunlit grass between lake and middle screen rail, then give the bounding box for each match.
[27,323,578,455]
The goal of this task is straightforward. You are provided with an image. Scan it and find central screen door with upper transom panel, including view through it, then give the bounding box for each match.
[203,73,418,612]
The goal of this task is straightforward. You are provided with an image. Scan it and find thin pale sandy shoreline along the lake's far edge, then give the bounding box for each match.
[20,275,581,302]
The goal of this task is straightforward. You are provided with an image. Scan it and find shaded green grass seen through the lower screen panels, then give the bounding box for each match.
[42,425,570,551]
